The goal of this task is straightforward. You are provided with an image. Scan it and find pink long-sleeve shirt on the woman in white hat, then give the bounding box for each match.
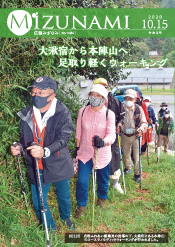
[76,105,116,169]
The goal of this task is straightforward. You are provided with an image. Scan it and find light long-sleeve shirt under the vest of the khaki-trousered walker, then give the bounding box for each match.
[122,104,148,133]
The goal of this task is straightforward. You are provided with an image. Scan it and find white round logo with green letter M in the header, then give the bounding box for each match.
[7,10,32,35]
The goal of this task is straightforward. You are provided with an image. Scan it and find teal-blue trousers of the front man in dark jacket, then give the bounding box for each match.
[31,170,71,230]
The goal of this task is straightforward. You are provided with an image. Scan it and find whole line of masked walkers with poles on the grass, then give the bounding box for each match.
[11,76,174,233]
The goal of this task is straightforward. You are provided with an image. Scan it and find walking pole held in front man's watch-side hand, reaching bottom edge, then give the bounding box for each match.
[31,142,51,247]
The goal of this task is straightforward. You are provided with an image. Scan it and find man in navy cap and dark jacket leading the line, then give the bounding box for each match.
[11,76,74,230]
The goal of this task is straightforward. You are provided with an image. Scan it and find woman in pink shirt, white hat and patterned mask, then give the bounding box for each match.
[76,84,116,218]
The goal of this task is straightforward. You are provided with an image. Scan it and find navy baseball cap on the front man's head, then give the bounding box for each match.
[28,76,57,91]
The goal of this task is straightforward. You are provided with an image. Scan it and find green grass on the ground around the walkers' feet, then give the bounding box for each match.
[0,149,175,247]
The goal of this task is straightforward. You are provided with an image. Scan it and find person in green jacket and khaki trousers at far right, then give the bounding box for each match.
[157,109,174,152]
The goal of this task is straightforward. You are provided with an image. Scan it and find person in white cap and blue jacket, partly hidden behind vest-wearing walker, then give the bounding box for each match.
[141,96,159,154]
